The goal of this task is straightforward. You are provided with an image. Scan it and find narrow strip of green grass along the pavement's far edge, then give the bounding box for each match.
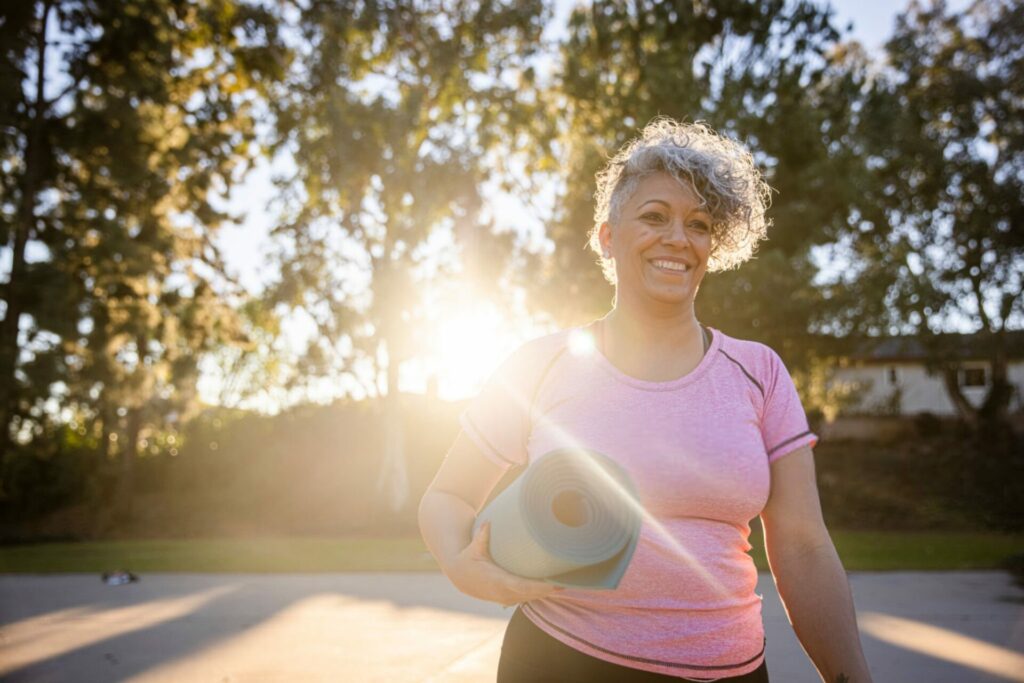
[0,530,1024,573]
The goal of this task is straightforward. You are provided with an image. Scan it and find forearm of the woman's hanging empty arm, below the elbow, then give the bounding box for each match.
[769,539,871,683]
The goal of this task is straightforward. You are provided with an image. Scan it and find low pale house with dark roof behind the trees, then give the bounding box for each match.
[833,331,1024,428]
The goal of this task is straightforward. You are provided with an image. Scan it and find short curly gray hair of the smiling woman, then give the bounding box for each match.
[590,117,771,284]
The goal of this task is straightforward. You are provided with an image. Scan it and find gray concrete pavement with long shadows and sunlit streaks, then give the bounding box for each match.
[0,571,1024,683]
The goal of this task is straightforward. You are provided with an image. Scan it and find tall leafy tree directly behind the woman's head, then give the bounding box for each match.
[512,0,849,368]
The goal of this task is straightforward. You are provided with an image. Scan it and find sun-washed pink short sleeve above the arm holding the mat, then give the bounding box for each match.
[459,344,537,468]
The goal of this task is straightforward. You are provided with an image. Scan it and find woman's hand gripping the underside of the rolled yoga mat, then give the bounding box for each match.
[447,522,561,607]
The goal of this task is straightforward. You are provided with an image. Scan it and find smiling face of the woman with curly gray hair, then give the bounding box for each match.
[600,173,712,305]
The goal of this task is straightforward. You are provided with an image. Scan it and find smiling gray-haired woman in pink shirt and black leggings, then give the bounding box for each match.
[420,119,870,683]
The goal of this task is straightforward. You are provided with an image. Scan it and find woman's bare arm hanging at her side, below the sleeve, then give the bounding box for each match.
[761,446,871,683]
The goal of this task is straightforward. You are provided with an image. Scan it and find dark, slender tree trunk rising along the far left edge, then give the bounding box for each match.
[0,2,51,456]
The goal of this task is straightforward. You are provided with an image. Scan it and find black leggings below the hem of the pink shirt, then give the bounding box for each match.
[498,609,768,683]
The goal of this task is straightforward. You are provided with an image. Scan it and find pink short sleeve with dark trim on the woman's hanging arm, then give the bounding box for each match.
[761,351,818,463]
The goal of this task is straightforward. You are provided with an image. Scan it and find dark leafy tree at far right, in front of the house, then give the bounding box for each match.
[834,0,1024,424]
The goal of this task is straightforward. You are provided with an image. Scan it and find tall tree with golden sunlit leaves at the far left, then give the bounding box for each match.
[0,0,287,511]
